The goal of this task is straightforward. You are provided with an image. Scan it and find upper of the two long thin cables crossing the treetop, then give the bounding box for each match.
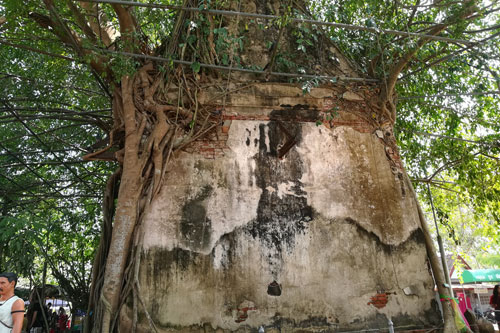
[83,0,473,45]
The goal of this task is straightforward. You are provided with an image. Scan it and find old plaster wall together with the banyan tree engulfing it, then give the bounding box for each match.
[2,0,496,332]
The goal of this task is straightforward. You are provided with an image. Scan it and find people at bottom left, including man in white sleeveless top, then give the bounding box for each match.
[0,273,68,333]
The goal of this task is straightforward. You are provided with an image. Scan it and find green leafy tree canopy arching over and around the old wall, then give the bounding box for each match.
[0,0,500,324]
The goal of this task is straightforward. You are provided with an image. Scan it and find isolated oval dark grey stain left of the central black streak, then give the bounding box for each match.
[180,185,213,250]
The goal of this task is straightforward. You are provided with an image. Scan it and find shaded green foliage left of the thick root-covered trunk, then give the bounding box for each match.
[0,1,113,308]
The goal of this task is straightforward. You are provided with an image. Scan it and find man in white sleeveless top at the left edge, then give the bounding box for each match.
[0,273,24,333]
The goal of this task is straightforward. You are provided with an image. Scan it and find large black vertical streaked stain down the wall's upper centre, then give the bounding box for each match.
[247,121,313,275]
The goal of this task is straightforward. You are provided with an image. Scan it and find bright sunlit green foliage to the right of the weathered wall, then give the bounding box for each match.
[311,0,500,250]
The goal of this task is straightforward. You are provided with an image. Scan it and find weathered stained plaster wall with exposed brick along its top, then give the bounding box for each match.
[122,84,439,332]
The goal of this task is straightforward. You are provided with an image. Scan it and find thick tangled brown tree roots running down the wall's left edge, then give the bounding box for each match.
[87,63,218,332]
